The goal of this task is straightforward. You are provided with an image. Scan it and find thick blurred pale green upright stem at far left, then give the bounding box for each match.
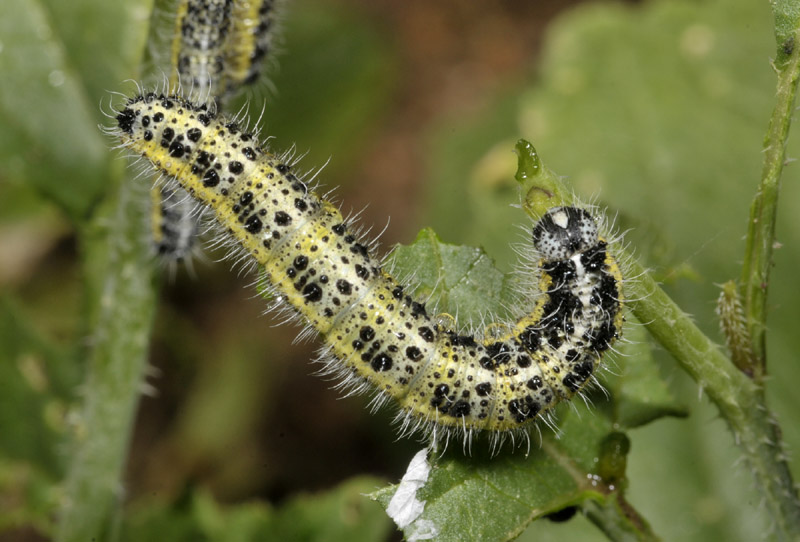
[56,171,155,542]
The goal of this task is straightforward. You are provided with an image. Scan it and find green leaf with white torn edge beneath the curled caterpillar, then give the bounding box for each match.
[371,404,652,541]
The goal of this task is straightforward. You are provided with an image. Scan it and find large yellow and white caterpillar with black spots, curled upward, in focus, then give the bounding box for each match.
[112,93,623,442]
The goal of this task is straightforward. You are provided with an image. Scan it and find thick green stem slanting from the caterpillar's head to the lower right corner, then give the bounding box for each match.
[623,262,800,540]
